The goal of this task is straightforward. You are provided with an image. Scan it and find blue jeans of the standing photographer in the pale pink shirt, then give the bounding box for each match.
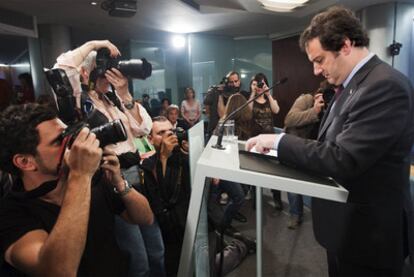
[115,167,166,277]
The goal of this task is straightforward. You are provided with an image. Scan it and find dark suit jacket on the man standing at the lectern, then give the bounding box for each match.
[278,56,414,268]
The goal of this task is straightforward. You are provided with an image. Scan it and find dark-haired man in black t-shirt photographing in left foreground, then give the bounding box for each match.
[0,104,153,276]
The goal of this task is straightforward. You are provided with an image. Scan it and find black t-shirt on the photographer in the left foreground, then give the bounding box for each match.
[0,172,129,276]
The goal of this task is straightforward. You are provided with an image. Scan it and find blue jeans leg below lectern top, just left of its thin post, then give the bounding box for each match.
[215,180,244,227]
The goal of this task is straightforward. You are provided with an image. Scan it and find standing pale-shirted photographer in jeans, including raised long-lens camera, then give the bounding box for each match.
[52,40,165,277]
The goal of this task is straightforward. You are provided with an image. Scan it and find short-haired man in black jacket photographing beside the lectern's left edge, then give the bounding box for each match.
[141,116,191,276]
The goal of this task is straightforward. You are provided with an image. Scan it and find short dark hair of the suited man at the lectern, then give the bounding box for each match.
[299,6,369,52]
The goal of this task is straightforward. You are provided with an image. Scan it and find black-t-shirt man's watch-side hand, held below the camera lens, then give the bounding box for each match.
[101,149,125,191]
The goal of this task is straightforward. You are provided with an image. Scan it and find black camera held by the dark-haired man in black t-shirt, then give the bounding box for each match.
[60,119,127,148]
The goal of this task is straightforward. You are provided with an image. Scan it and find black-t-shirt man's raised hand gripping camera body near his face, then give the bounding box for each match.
[65,127,102,177]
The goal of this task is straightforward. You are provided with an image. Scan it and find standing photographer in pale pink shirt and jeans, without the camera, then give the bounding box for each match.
[54,41,165,276]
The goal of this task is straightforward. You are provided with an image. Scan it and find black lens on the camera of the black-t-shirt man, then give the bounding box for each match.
[91,119,127,148]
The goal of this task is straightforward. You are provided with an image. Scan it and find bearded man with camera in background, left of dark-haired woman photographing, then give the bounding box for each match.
[203,71,240,136]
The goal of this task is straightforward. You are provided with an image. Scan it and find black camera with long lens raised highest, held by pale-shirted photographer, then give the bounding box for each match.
[94,48,152,80]
